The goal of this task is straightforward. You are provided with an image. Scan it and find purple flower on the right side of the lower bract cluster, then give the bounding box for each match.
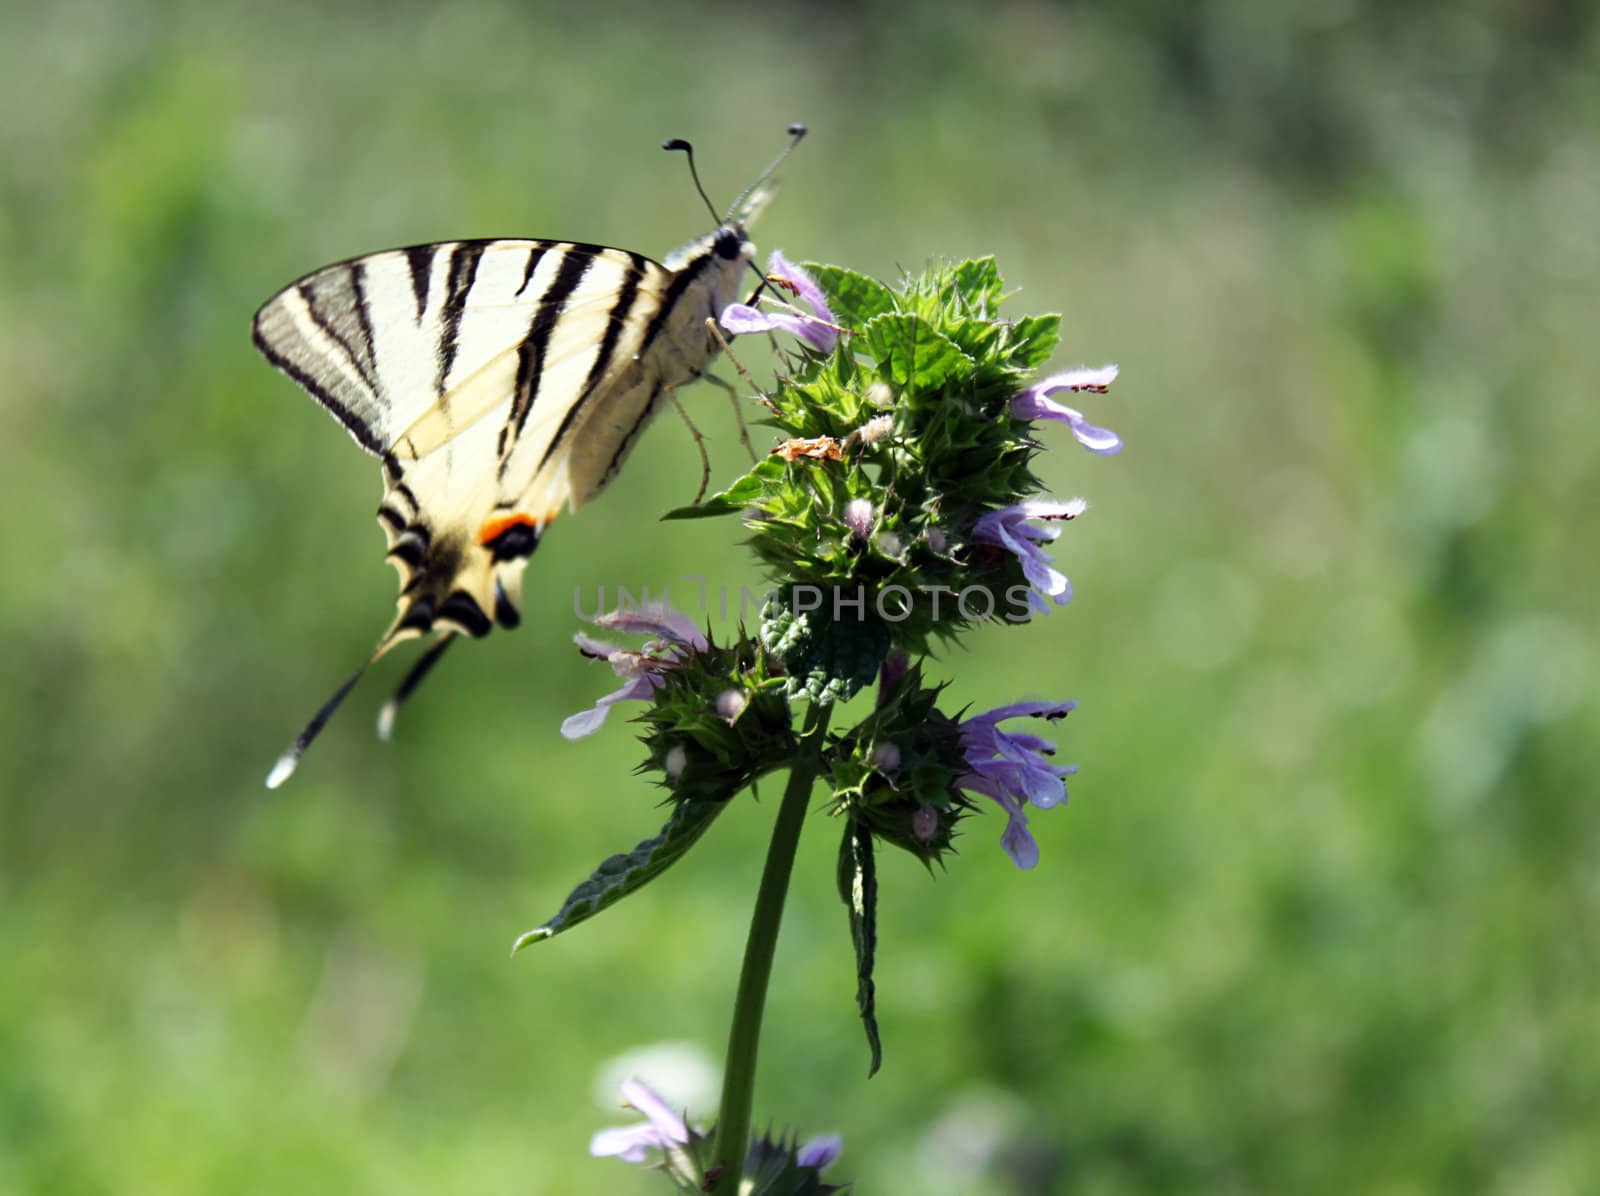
[955,702,1078,868]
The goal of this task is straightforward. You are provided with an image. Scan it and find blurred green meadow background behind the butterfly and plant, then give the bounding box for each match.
[0,0,1600,1196]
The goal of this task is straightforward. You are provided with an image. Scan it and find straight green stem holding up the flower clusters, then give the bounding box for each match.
[717,702,834,1194]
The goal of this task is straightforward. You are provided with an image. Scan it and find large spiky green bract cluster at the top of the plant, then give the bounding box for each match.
[669,257,1059,658]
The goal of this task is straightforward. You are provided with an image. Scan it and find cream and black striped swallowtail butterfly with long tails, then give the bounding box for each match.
[253,125,805,788]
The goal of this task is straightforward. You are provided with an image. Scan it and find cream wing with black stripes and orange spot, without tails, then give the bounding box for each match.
[254,240,675,646]
